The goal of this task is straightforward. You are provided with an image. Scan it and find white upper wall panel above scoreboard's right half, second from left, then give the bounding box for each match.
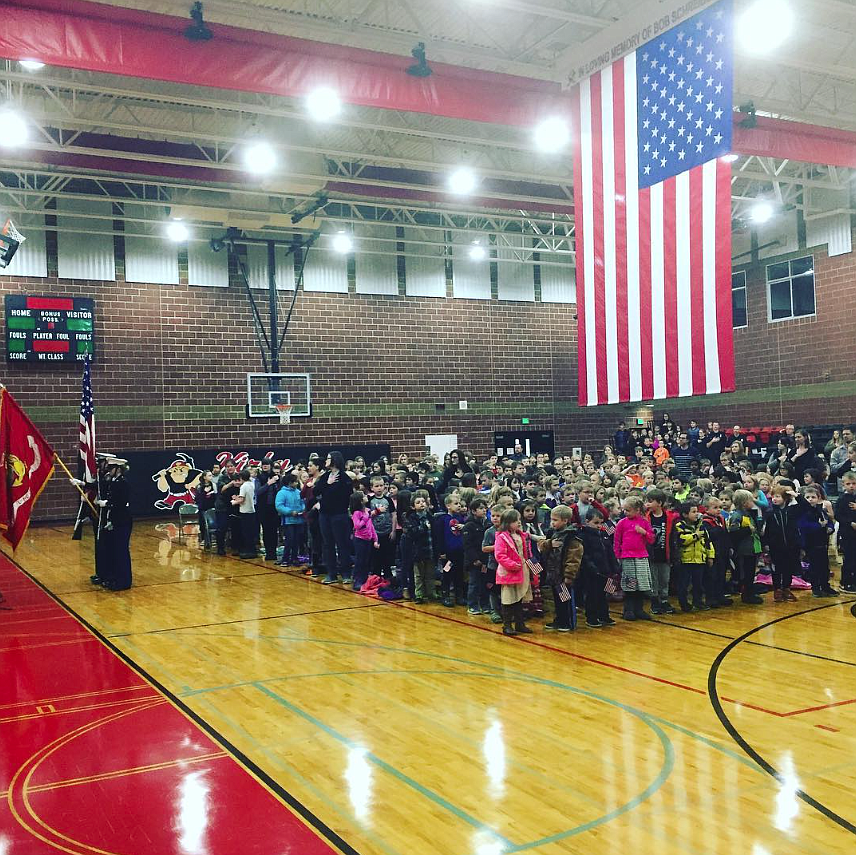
[57,197,116,282]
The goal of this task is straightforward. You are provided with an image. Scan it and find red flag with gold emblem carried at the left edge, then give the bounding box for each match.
[0,389,54,549]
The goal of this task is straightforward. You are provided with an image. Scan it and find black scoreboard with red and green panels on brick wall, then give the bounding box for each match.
[6,294,95,362]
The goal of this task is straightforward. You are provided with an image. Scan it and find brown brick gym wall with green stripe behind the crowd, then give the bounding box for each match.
[0,233,856,517]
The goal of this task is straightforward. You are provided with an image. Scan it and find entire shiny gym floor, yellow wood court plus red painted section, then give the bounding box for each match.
[0,522,856,855]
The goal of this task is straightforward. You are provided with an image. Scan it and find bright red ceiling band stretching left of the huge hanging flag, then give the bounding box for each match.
[0,0,568,127]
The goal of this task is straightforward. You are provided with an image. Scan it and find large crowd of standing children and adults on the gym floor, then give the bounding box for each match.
[192,415,856,635]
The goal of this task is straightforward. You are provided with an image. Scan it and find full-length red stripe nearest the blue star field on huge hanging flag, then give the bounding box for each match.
[612,62,636,401]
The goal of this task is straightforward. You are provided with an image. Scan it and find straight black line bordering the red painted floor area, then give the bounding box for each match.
[3,553,360,855]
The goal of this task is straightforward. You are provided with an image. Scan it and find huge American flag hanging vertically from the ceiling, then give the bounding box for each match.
[573,0,734,405]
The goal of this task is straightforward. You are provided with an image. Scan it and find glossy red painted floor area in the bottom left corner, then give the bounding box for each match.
[0,556,338,855]
